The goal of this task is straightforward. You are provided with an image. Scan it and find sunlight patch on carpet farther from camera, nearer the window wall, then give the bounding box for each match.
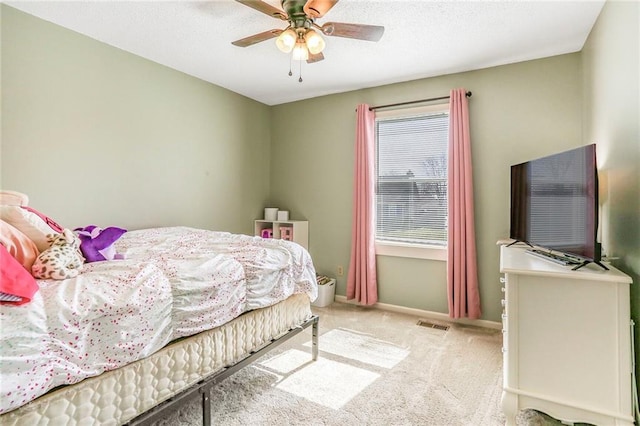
[305,329,409,368]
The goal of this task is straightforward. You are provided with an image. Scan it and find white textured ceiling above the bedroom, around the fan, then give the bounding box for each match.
[6,0,604,105]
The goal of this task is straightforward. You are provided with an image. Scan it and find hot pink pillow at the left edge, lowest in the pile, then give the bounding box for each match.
[0,244,38,305]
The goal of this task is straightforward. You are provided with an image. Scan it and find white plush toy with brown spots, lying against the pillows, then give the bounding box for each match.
[31,229,84,280]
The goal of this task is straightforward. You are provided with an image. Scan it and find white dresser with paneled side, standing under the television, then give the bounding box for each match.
[500,246,634,426]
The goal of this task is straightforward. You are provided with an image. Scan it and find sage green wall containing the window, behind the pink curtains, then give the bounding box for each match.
[270,53,583,321]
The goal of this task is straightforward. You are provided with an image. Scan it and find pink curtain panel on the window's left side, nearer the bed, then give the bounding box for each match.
[347,104,378,305]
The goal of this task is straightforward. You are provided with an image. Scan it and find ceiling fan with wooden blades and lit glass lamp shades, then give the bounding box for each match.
[231,0,384,63]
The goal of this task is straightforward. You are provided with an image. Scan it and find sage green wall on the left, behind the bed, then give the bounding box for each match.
[0,5,271,233]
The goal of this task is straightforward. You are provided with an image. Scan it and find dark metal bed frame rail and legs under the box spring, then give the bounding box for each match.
[125,315,320,426]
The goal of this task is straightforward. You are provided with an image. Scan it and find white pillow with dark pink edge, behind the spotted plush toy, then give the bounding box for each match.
[0,205,63,252]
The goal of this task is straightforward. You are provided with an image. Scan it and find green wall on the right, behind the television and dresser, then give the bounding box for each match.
[582,1,640,402]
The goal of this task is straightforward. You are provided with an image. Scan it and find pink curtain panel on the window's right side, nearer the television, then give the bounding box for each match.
[447,89,481,319]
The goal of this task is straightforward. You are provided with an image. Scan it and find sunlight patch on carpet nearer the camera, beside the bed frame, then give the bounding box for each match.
[260,349,380,410]
